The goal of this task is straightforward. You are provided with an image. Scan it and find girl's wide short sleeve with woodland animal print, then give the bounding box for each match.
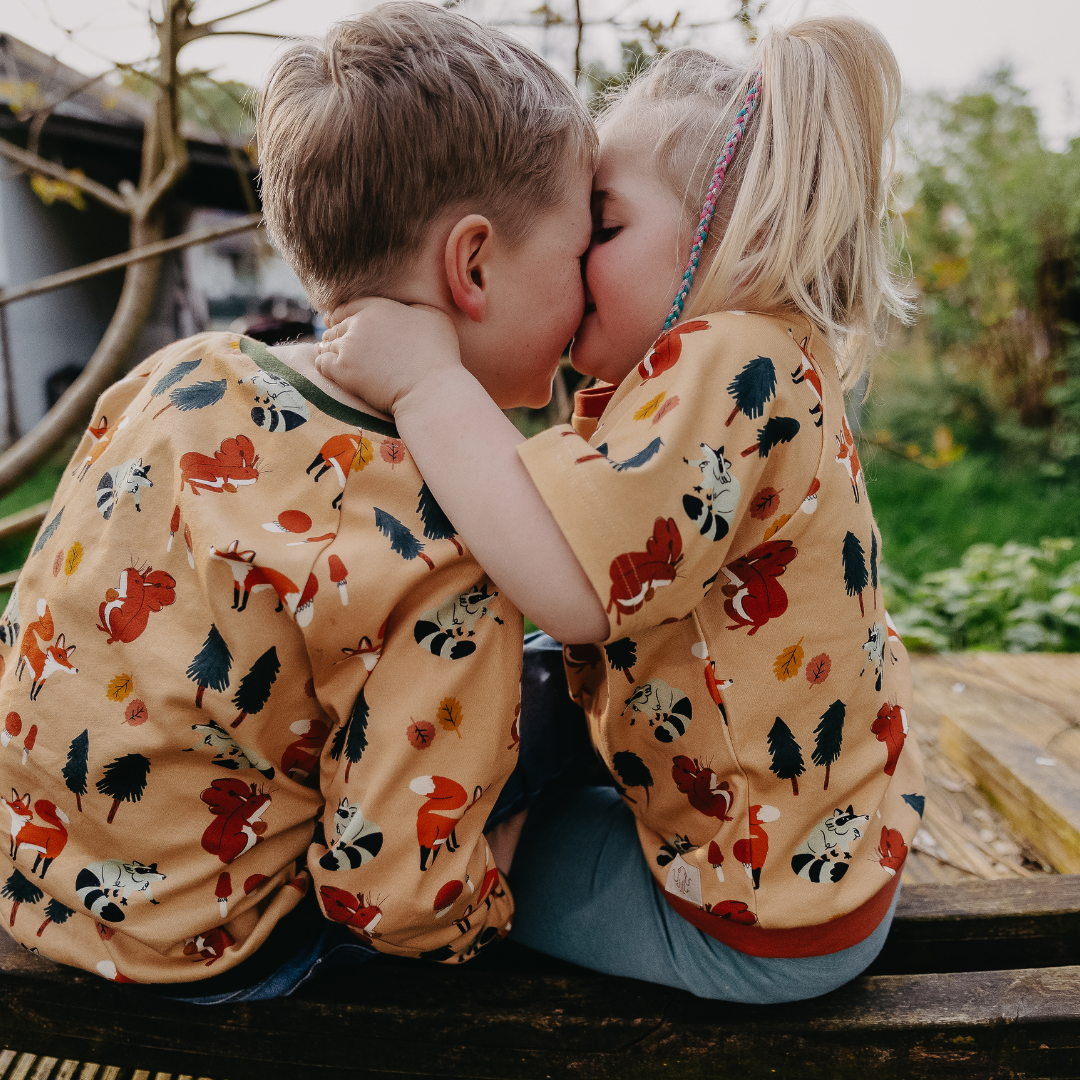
[518,312,823,640]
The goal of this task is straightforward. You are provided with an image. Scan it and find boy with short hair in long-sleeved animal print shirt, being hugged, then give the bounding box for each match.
[0,3,596,1000]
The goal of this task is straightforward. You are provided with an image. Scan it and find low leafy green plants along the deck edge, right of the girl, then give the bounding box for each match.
[881,539,1080,652]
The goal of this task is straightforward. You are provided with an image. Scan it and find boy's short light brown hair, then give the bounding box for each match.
[258,0,597,311]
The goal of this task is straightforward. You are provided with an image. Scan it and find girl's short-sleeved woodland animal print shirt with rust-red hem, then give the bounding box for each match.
[519,312,923,957]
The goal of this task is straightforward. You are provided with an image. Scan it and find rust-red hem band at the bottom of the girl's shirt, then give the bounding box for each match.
[653,869,901,959]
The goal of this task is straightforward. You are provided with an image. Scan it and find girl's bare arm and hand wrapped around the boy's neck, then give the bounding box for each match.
[318,300,608,644]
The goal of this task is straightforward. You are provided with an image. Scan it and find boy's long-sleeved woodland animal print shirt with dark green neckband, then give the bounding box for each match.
[0,334,522,983]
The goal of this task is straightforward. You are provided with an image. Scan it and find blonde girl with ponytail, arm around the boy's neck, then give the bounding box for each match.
[321,18,923,1002]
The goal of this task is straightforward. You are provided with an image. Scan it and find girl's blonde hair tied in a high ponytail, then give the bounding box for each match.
[600,17,910,388]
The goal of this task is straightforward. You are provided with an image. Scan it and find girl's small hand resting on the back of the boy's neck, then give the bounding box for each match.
[315,297,461,414]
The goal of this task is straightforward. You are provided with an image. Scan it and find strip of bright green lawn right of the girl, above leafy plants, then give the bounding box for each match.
[863,451,1080,581]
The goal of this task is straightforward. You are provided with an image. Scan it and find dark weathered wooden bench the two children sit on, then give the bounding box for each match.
[0,875,1080,1080]
